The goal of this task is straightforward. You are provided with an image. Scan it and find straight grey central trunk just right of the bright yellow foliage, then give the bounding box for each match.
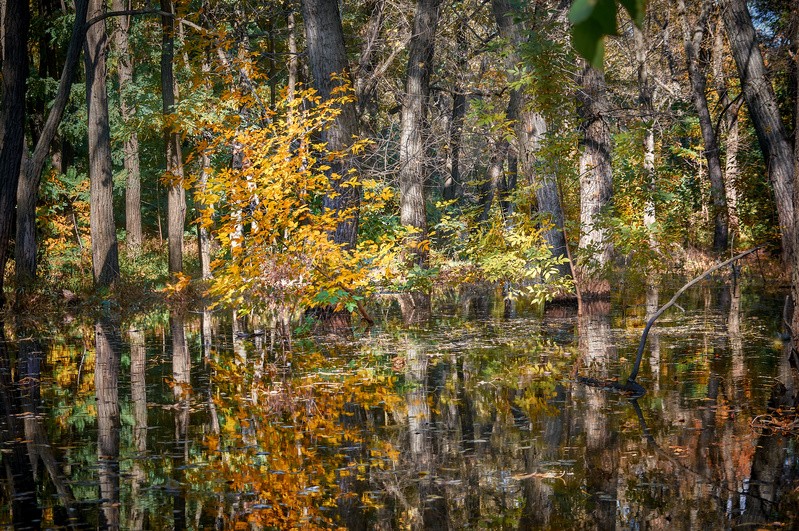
[399,0,441,267]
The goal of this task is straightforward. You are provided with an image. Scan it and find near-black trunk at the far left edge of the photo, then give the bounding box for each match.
[0,0,30,305]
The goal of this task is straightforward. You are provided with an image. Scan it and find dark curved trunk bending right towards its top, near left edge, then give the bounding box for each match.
[14,0,89,291]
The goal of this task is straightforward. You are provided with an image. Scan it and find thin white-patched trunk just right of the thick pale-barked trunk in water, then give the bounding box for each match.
[633,24,658,251]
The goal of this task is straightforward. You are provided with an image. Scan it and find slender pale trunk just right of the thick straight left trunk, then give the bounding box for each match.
[111,0,142,255]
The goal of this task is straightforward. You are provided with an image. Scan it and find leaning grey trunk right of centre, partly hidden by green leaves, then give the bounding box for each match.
[492,0,569,275]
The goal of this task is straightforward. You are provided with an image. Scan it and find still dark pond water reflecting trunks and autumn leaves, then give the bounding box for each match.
[0,280,799,530]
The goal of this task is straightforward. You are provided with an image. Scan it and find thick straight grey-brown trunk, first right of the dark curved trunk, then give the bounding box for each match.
[84,0,119,286]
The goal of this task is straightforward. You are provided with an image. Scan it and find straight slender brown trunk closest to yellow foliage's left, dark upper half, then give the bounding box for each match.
[161,0,186,274]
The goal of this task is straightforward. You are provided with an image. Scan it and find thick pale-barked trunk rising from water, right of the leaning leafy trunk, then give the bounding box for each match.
[577,64,613,298]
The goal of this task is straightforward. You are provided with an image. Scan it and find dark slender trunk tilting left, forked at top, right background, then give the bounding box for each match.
[677,0,729,254]
